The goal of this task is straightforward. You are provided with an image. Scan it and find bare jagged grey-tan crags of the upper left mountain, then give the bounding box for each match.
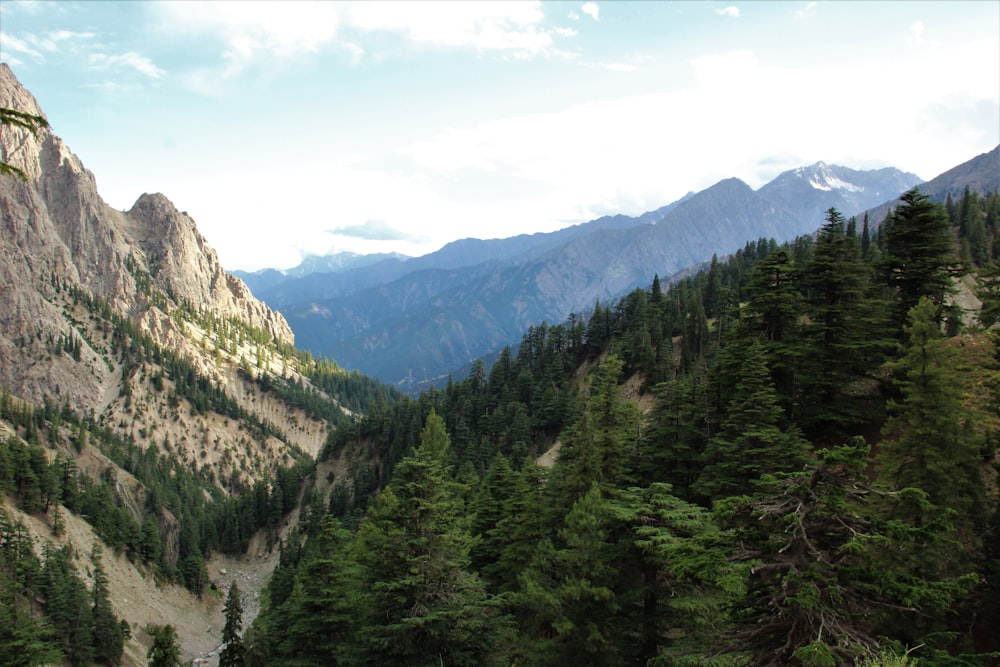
[0,64,293,409]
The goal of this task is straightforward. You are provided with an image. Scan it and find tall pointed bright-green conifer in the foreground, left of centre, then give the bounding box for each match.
[358,410,509,665]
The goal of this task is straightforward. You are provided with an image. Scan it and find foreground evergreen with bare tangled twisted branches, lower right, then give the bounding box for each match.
[720,438,974,665]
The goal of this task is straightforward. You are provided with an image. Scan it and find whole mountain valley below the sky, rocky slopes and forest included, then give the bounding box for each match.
[0,60,1000,666]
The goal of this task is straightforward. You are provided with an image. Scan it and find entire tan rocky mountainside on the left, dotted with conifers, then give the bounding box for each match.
[0,63,396,665]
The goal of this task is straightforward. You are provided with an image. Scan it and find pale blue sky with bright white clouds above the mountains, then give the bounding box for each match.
[0,0,1000,270]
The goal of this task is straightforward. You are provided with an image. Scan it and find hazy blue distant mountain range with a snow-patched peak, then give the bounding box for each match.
[239,154,936,388]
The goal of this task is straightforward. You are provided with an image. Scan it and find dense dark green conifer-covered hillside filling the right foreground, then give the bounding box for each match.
[244,190,1000,665]
